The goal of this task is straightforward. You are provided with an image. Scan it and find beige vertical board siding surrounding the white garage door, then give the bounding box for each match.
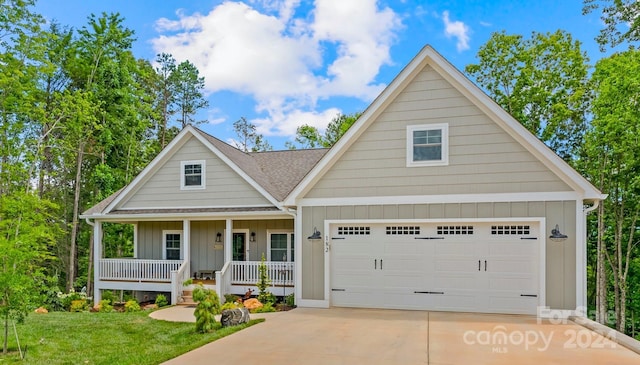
[302,201,579,309]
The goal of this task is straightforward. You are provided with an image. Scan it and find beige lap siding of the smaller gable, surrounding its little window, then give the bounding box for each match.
[123,137,270,209]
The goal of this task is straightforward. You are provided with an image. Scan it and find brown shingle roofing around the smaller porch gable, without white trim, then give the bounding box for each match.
[82,128,329,216]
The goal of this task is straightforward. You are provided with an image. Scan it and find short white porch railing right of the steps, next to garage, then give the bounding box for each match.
[231,261,295,286]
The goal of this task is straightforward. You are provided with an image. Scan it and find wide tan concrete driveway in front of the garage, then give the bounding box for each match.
[155,308,640,365]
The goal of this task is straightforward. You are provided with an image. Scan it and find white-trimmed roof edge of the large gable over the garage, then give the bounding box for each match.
[284,45,606,206]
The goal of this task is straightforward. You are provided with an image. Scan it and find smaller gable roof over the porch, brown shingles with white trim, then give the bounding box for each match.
[82,125,328,218]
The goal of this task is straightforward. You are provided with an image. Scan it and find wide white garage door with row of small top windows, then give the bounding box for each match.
[330,222,541,314]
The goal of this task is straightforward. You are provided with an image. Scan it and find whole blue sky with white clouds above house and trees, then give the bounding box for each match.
[35,0,603,149]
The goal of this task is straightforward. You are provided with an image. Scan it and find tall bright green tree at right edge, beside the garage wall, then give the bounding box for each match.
[580,50,640,332]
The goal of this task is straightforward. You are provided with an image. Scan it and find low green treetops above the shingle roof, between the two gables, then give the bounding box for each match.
[289,112,362,148]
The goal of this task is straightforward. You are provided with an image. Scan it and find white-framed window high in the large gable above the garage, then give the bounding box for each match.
[407,123,449,167]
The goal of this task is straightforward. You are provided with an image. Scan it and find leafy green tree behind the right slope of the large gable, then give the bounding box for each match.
[465,30,590,162]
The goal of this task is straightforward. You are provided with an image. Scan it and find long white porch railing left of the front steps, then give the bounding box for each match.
[98,258,182,282]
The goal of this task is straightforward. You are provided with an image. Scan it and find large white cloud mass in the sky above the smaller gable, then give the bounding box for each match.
[151,0,400,135]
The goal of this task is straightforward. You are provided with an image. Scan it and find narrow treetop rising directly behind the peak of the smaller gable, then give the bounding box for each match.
[170,61,209,128]
